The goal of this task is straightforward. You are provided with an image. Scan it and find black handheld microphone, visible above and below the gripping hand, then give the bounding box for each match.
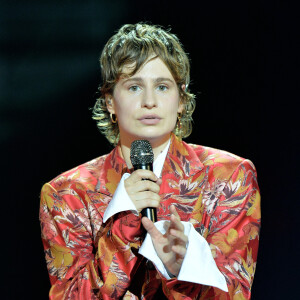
[130,140,157,222]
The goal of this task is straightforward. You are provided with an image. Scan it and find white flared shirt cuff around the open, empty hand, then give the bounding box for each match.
[139,221,228,292]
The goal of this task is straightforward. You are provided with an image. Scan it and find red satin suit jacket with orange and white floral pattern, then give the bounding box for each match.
[40,135,260,300]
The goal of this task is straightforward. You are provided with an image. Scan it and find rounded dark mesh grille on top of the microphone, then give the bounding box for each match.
[130,140,154,166]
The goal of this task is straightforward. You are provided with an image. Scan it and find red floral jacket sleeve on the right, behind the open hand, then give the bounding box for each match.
[158,160,260,300]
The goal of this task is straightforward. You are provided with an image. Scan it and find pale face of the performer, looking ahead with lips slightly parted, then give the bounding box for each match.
[107,58,182,147]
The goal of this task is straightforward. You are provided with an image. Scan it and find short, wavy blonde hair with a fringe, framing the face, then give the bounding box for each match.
[93,23,196,145]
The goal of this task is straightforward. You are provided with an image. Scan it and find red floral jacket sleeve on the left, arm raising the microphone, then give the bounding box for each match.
[40,184,141,300]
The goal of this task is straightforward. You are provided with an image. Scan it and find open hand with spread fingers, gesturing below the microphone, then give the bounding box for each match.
[142,205,188,276]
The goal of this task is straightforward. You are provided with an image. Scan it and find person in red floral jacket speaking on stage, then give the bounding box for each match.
[40,23,260,299]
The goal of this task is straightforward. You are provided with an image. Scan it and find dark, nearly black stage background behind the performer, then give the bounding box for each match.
[0,0,299,299]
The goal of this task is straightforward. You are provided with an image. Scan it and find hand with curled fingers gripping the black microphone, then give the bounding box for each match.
[124,170,161,213]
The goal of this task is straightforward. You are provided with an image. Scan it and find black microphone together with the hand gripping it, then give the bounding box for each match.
[124,140,161,222]
